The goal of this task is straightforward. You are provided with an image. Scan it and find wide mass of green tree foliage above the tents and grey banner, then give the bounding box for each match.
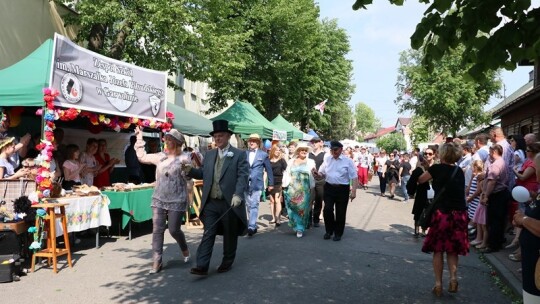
[62,0,354,135]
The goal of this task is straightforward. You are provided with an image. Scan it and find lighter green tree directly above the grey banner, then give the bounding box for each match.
[66,0,250,81]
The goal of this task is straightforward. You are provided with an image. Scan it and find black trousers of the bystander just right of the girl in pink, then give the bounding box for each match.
[486,190,510,250]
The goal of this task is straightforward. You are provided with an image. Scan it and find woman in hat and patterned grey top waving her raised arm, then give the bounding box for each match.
[135,127,191,274]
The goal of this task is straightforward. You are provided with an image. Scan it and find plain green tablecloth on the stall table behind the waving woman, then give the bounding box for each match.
[101,189,154,228]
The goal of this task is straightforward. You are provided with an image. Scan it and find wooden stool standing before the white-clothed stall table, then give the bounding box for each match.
[32,203,73,273]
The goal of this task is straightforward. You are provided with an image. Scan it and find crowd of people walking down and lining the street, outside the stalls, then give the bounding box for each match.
[127,121,540,304]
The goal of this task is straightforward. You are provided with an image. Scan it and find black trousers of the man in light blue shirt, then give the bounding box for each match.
[323,183,350,236]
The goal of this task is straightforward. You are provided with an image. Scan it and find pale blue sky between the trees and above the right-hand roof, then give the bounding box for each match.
[318,0,532,127]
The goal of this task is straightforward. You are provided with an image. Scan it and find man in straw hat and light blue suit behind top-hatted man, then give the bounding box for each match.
[245,134,274,236]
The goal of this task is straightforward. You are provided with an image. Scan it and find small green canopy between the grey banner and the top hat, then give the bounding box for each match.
[167,103,213,137]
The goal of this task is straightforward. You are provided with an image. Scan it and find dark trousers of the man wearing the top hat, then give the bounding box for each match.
[193,199,240,270]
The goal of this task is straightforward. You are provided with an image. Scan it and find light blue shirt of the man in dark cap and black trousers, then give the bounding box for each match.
[319,155,358,185]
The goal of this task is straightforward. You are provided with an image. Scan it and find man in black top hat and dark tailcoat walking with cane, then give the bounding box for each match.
[184,120,249,275]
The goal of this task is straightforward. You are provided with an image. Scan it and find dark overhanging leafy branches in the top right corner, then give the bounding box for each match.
[353,0,540,79]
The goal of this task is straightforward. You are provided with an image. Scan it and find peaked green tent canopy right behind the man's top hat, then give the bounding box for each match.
[210,101,285,139]
